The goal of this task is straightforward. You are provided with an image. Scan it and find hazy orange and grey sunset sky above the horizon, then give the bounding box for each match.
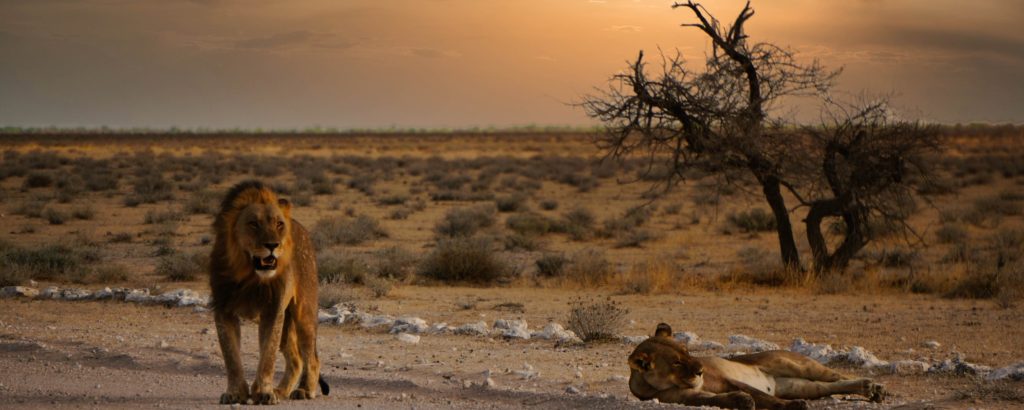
[0,0,1024,128]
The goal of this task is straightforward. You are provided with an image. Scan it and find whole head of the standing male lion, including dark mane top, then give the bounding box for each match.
[215,181,292,279]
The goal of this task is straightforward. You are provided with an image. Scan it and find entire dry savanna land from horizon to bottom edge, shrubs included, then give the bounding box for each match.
[0,127,1024,409]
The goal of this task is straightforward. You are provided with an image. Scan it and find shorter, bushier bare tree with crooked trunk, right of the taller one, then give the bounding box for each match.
[791,99,939,272]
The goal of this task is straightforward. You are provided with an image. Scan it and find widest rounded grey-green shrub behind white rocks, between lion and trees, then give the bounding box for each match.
[419,237,514,285]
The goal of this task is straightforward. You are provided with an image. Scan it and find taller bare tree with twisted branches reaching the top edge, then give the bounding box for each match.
[583,1,838,267]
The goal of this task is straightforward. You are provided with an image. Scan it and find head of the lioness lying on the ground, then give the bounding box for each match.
[630,323,703,391]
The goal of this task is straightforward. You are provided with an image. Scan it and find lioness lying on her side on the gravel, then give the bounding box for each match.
[629,323,885,409]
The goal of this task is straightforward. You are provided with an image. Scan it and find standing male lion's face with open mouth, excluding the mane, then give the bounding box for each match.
[232,200,292,279]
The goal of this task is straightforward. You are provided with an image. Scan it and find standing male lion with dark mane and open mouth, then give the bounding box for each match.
[210,180,330,404]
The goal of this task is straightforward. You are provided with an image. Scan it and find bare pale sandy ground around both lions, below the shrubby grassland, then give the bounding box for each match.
[0,287,1024,409]
